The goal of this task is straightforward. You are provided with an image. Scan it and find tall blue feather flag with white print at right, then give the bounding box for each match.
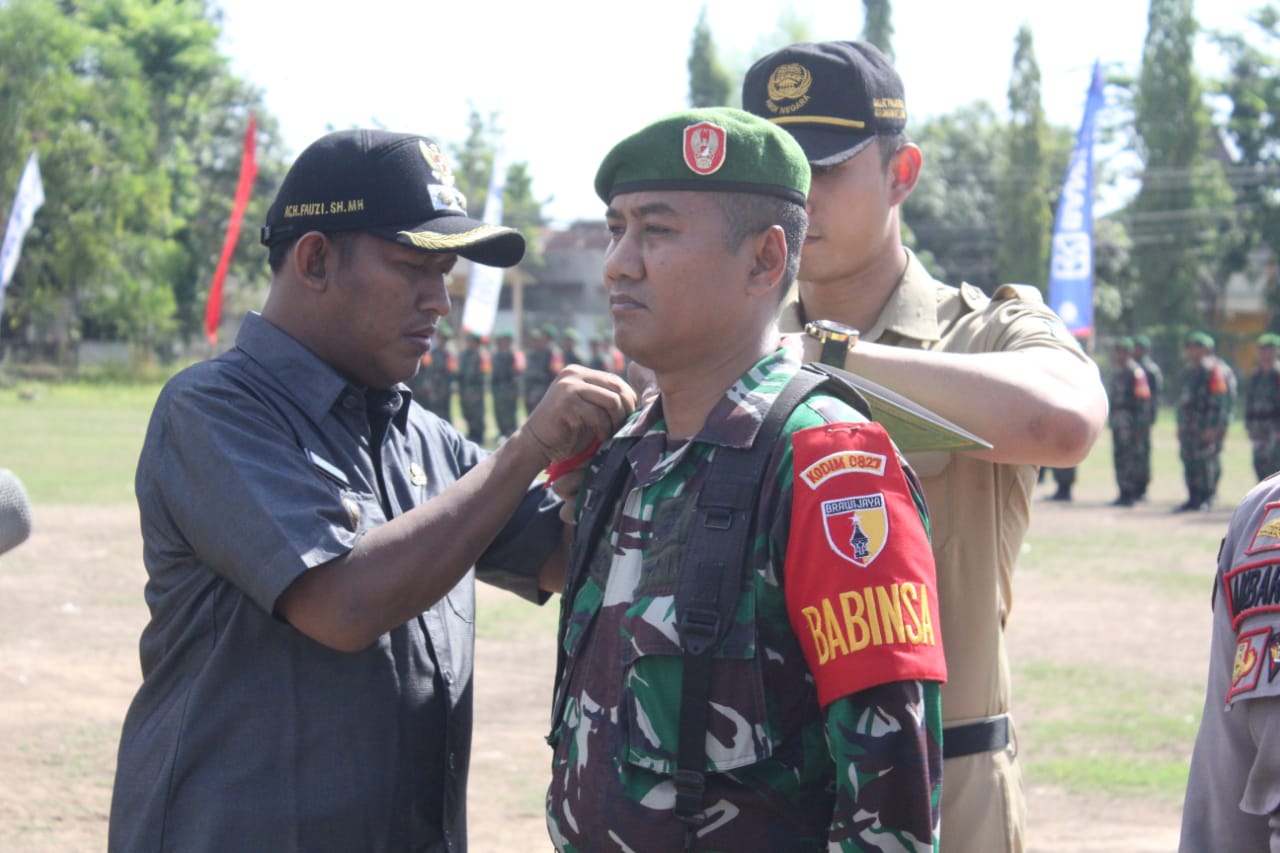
[1048,61,1102,337]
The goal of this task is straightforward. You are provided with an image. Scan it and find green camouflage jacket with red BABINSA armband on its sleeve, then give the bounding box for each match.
[547,351,945,850]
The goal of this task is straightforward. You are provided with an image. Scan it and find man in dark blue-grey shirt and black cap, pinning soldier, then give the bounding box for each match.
[110,131,634,853]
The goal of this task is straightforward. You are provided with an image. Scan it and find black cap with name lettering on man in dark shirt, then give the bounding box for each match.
[262,131,525,266]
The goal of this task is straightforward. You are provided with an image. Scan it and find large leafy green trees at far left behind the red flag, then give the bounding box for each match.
[0,0,283,351]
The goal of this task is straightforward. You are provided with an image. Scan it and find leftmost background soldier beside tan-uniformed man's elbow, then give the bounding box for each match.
[1107,338,1151,506]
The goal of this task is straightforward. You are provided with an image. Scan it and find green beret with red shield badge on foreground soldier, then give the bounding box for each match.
[595,106,809,205]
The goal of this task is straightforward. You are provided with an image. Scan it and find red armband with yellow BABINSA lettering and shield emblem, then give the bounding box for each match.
[783,423,947,707]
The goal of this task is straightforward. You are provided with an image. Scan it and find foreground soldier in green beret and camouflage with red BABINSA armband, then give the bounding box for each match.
[547,109,945,852]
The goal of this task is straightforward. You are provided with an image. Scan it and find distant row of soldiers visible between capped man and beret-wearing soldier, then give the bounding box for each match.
[410,321,626,444]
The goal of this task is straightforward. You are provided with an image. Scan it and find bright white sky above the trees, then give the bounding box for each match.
[220,0,1262,222]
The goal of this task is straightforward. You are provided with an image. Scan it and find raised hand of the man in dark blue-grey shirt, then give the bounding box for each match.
[512,365,636,466]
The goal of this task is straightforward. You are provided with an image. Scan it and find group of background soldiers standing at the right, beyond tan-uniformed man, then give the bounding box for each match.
[1108,332,1280,512]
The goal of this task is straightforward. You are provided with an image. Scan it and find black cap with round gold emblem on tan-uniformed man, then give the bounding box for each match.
[742,41,906,167]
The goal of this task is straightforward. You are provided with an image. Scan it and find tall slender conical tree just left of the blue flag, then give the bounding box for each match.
[996,24,1053,291]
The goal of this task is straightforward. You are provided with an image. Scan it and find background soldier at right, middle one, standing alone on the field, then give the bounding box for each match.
[1176,332,1235,512]
